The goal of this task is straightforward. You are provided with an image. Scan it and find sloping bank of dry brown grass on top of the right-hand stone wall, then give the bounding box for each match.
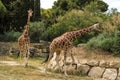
[75,47,120,61]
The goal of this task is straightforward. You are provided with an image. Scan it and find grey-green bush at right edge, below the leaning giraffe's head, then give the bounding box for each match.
[86,30,120,53]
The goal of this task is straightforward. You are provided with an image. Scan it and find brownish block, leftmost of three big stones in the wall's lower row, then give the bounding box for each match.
[77,64,90,75]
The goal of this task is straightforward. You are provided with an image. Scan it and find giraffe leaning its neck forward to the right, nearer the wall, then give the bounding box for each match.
[45,23,100,76]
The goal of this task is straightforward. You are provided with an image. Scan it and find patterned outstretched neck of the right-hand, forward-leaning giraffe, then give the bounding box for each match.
[63,26,94,42]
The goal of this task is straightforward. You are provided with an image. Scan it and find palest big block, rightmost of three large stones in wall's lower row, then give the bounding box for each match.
[103,68,117,80]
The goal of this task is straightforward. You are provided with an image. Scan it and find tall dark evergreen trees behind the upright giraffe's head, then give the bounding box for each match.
[0,0,40,33]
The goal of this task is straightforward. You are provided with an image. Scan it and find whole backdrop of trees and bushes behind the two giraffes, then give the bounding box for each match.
[0,0,120,54]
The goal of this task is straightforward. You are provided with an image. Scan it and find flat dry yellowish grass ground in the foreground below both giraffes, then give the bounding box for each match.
[0,56,93,80]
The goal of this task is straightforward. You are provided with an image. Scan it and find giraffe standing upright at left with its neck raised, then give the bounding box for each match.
[18,9,33,67]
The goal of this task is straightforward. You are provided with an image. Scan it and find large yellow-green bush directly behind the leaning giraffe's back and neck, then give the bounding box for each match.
[43,10,102,42]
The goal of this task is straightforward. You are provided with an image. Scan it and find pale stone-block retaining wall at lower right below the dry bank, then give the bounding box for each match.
[49,57,120,80]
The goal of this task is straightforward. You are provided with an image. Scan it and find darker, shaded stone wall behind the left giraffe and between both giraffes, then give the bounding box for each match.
[8,40,50,57]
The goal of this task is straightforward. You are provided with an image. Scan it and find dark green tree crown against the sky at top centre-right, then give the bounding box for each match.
[53,0,108,16]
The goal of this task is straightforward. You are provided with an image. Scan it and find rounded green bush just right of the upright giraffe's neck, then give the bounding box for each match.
[30,22,45,42]
